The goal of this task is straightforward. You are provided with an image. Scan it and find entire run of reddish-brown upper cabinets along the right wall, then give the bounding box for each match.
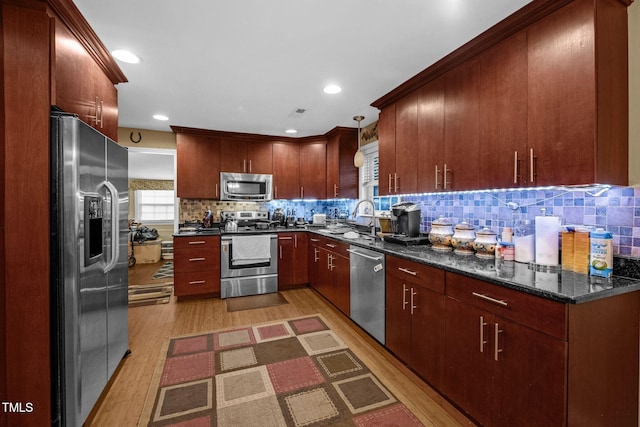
[372,0,629,191]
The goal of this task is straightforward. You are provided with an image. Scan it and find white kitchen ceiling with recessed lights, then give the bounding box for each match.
[74,0,529,136]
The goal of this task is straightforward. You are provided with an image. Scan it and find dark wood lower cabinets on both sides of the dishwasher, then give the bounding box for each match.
[308,234,640,427]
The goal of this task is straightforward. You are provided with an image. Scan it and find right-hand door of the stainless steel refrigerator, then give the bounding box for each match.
[105,139,129,378]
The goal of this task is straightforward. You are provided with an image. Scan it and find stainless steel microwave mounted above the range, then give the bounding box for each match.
[220,172,273,202]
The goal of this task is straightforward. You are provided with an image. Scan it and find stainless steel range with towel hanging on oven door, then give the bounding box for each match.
[220,211,278,298]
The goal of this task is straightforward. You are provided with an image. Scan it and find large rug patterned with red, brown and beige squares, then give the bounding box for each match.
[139,315,422,427]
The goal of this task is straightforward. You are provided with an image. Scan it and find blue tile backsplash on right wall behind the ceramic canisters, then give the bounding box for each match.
[402,187,640,257]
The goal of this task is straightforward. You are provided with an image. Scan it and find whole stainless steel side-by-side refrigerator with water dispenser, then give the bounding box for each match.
[50,111,129,426]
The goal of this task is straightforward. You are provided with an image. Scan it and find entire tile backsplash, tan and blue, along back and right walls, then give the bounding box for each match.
[180,187,640,258]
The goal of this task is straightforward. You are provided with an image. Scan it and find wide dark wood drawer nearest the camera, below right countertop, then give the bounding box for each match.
[446,272,567,340]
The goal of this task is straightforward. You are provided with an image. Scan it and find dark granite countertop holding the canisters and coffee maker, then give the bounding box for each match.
[309,230,640,304]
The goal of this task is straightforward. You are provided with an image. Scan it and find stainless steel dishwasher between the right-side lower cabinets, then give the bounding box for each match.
[349,245,385,344]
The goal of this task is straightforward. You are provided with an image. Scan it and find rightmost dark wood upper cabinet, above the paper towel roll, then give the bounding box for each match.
[527,0,628,185]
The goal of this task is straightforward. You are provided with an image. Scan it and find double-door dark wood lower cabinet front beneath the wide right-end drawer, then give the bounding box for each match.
[443,298,567,427]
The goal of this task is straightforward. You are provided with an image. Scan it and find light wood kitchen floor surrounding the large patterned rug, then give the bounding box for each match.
[86,270,473,427]
